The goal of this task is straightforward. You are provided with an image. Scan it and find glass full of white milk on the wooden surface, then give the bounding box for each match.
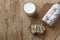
[24,2,36,15]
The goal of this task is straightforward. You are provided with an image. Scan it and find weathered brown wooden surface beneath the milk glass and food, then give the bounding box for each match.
[0,0,60,40]
